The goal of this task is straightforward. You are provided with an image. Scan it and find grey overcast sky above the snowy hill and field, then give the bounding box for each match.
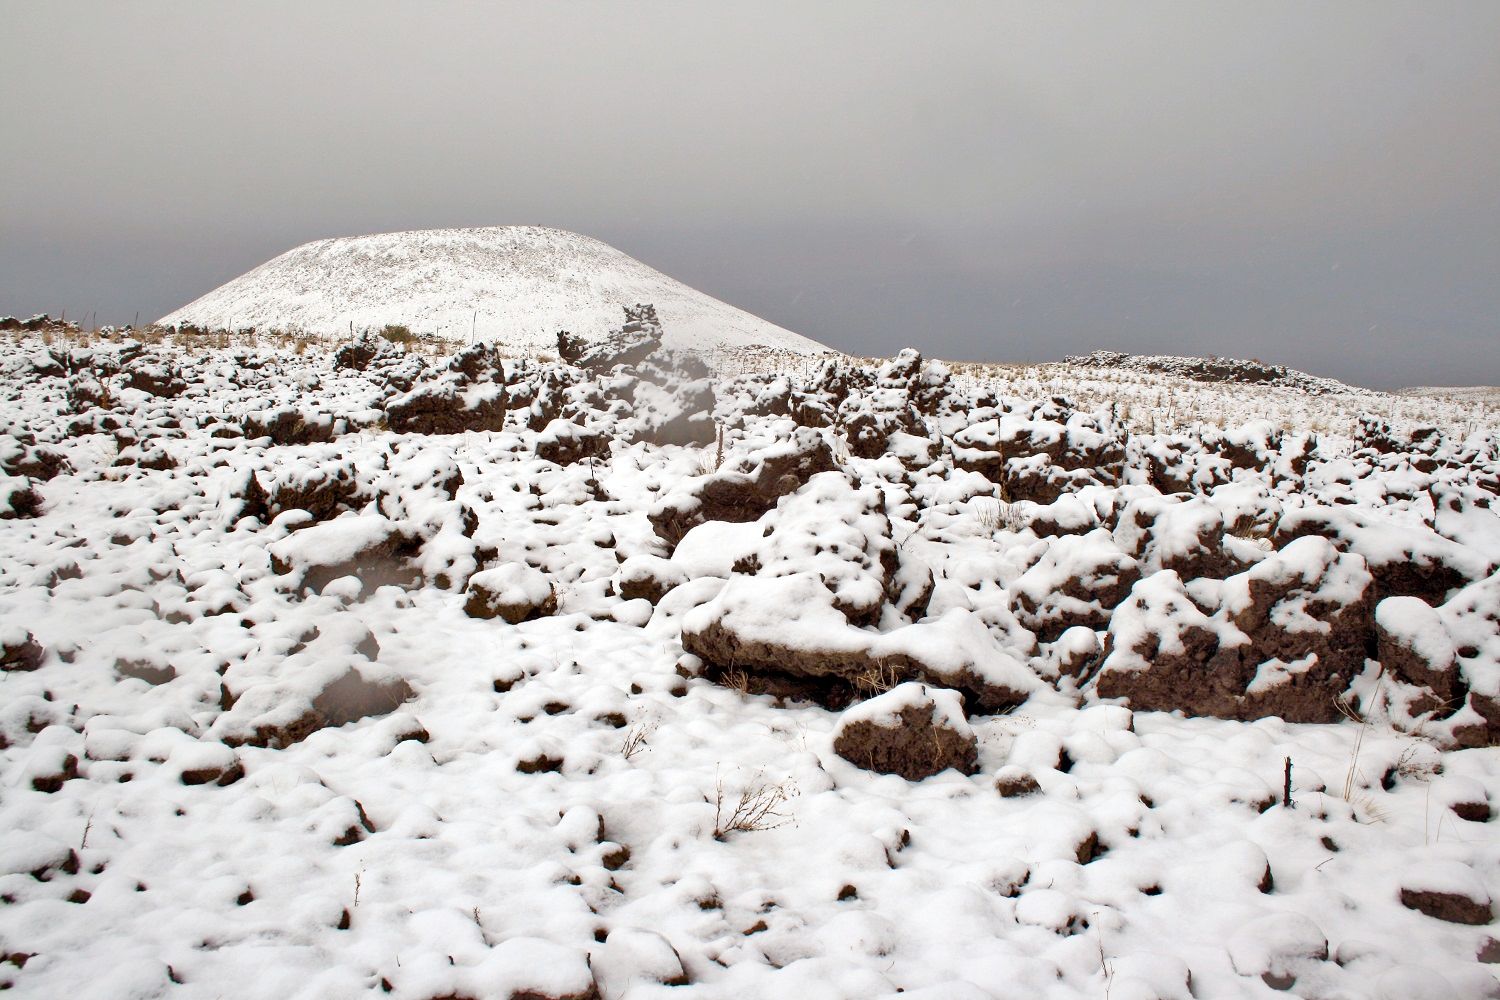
[0,0,1500,387]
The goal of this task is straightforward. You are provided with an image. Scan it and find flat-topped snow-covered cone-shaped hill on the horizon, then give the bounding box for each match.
[159,226,828,354]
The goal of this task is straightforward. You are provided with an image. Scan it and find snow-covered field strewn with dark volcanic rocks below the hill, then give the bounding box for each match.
[0,325,1500,1000]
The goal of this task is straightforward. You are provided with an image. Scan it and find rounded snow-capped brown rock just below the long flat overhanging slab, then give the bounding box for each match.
[834,682,980,781]
